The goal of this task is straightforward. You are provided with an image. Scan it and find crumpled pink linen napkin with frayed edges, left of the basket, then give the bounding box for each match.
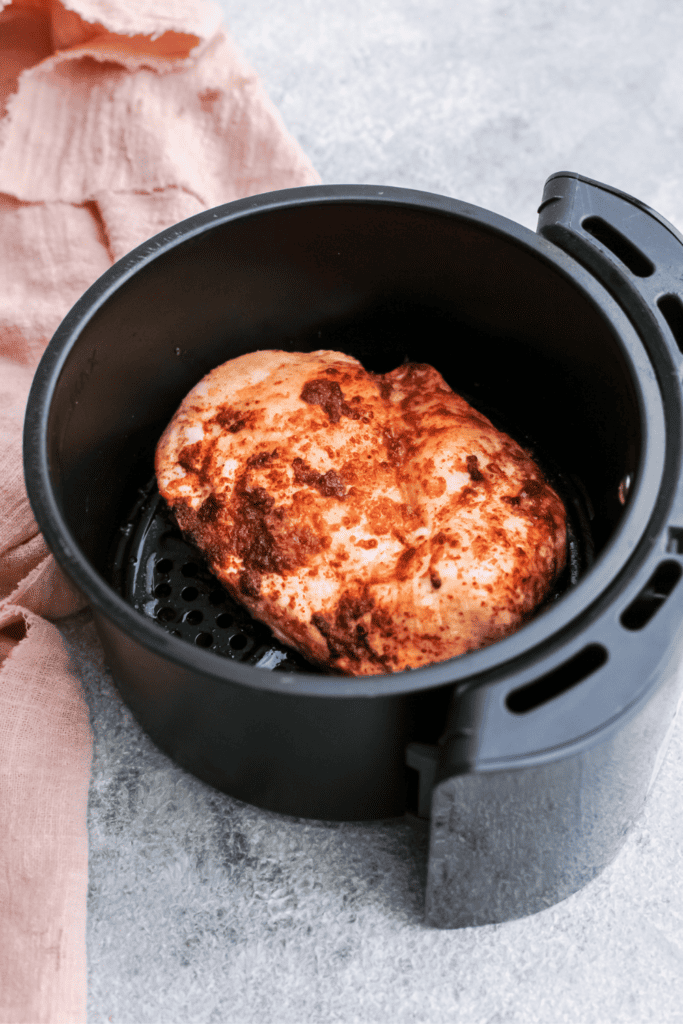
[0,0,319,1024]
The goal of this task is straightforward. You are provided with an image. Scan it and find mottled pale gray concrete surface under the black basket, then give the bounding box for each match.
[62,0,683,1024]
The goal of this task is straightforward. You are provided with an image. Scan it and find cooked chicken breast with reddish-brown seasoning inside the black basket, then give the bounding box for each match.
[156,351,566,675]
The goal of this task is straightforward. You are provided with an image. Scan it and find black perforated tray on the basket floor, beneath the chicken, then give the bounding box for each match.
[112,462,592,672]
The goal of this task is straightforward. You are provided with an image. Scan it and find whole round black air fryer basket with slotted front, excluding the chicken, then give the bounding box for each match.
[25,173,683,927]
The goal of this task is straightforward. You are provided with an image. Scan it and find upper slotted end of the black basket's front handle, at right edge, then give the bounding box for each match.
[537,171,683,366]
